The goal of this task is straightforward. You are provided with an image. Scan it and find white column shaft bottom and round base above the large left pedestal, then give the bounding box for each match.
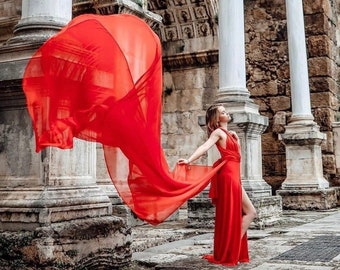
[8,0,72,43]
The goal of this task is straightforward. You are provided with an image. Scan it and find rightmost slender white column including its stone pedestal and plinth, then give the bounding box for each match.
[277,0,334,209]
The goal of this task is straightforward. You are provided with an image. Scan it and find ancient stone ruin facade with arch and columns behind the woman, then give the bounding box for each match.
[0,0,340,267]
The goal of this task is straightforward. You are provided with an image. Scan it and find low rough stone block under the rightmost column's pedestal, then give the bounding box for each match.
[276,188,339,210]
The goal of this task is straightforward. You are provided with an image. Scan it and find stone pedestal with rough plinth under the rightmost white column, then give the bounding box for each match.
[277,121,337,210]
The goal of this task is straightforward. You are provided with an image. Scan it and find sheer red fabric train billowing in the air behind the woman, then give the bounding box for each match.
[23,14,222,225]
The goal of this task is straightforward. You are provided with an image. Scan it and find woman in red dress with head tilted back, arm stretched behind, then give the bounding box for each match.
[178,104,256,266]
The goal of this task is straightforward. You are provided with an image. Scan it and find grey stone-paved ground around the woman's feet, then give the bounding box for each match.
[126,208,340,270]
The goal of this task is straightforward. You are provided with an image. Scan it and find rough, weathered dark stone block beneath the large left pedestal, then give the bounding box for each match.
[0,217,132,270]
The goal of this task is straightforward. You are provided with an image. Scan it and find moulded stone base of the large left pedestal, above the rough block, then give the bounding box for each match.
[0,186,112,231]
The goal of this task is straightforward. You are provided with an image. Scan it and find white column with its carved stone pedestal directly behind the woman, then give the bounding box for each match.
[188,0,282,229]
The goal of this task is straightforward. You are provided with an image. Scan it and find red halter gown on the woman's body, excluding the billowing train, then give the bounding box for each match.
[204,129,249,266]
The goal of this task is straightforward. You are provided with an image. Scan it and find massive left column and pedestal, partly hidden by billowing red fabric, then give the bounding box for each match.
[0,0,131,269]
